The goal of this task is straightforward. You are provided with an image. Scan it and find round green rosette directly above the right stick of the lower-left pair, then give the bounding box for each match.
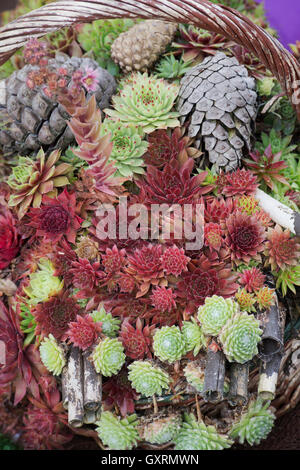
[92,338,125,377]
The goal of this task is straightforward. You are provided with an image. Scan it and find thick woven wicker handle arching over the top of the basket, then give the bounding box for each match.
[0,0,300,120]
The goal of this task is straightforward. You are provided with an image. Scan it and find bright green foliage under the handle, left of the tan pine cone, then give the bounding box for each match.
[78,18,136,76]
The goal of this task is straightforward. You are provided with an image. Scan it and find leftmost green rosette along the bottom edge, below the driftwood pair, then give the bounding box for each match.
[96,411,139,450]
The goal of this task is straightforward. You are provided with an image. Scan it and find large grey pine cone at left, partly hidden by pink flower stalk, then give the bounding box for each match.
[0,54,116,155]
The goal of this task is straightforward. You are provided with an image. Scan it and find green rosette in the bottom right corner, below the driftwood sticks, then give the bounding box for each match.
[230,400,275,446]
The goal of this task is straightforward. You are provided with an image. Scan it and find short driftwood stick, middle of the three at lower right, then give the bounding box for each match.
[228,362,249,406]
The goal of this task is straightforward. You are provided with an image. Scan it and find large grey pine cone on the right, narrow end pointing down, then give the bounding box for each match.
[178,52,257,171]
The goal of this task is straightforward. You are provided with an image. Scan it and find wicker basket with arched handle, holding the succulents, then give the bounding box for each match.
[0,0,300,449]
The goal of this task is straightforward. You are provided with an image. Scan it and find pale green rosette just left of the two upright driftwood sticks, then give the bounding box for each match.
[40,334,66,375]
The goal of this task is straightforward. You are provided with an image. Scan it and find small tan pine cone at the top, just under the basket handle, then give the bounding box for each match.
[111,20,177,73]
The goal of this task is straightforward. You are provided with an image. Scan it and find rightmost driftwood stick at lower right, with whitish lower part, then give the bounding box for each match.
[258,353,282,400]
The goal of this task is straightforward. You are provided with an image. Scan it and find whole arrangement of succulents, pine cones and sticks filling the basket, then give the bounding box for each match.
[0,0,300,452]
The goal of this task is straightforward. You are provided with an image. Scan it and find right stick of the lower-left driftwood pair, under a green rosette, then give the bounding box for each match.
[82,351,102,411]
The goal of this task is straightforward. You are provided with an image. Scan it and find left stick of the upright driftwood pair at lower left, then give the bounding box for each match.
[68,346,84,428]
